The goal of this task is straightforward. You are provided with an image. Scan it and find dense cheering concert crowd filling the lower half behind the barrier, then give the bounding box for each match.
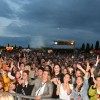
[0,50,100,100]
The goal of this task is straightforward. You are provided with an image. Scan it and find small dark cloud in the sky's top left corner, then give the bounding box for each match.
[0,0,13,18]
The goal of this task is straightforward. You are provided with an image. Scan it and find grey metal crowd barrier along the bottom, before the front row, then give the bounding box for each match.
[9,93,61,100]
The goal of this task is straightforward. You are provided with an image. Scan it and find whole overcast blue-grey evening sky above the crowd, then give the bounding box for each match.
[0,0,100,47]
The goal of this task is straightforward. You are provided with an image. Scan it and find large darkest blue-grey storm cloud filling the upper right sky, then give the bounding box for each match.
[19,0,100,30]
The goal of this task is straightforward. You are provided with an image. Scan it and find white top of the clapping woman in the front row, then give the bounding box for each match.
[59,84,73,100]
